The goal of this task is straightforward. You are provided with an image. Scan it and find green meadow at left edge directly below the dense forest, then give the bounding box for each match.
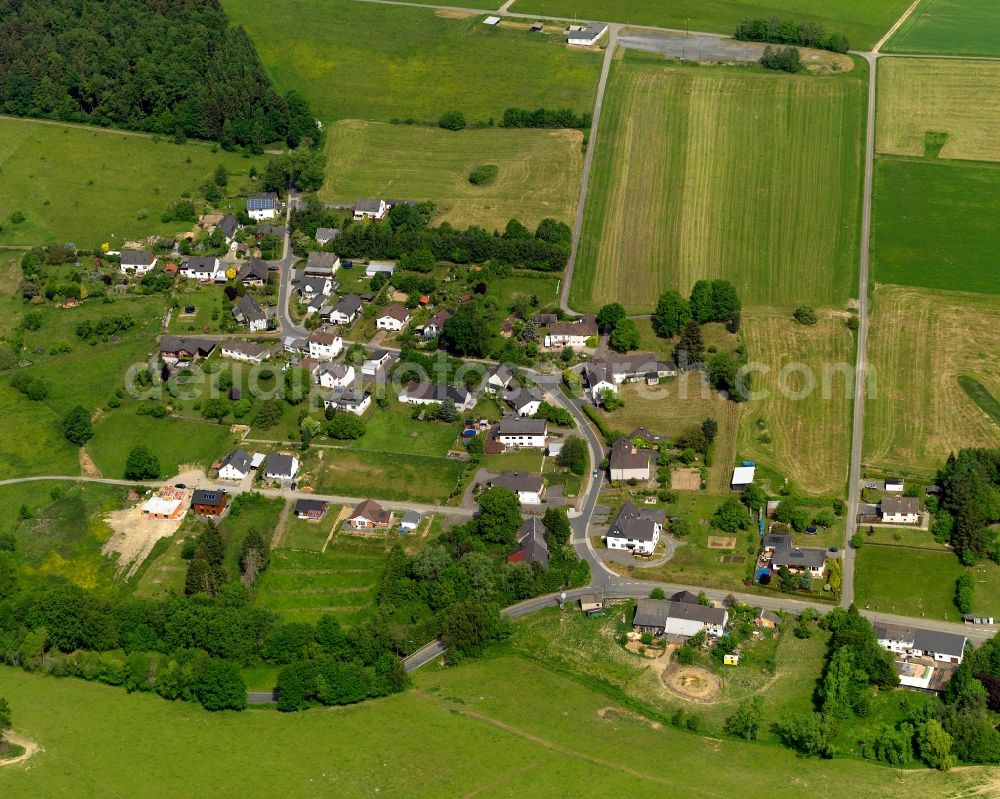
[0,119,264,248]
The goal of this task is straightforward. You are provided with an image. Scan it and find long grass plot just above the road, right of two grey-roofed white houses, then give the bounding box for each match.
[306,450,465,503]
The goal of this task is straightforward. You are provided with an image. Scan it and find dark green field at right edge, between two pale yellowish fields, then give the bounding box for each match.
[871,157,1000,294]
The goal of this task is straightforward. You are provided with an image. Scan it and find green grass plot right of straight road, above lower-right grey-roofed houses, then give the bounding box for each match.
[854,545,1000,621]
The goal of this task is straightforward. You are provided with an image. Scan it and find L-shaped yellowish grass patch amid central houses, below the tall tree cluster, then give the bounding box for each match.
[597,372,743,491]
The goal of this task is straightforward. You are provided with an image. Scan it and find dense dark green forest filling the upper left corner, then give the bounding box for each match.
[0,0,317,152]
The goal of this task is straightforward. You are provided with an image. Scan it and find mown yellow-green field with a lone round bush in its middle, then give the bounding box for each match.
[319,119,583,232]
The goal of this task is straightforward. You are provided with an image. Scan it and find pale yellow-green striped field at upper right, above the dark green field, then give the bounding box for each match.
[876,58,1000,161]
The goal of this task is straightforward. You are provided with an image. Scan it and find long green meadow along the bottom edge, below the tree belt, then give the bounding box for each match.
[0,657,995,799]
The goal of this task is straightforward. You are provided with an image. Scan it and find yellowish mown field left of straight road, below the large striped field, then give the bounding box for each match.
[737,309,855,496]
